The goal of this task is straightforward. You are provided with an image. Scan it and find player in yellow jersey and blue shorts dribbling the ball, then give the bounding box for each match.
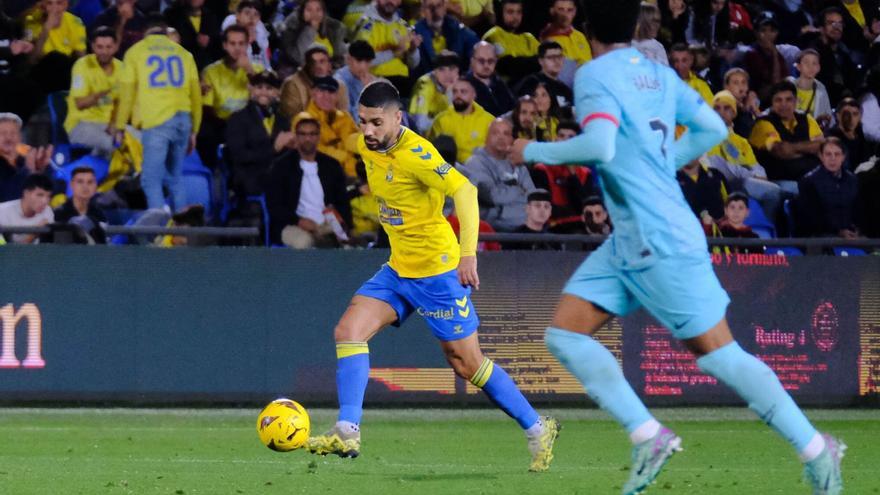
[307,80,559,471]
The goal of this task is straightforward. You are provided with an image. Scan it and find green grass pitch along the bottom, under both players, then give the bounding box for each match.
[0,409,880,495]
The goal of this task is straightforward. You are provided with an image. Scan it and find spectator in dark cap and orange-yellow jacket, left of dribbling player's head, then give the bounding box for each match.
[306,76,359,177]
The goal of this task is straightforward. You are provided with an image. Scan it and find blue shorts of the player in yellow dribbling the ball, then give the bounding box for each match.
[356,264,480,342]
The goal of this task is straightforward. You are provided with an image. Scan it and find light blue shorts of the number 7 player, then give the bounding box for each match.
[563,242,730,340]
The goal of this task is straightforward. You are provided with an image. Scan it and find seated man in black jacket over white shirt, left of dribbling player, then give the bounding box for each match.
[266,112,352,249]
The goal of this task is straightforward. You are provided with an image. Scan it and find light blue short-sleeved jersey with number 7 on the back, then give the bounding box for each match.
[574,48,707,267]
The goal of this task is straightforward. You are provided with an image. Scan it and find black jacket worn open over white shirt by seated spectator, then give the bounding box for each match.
[266,150,352,244]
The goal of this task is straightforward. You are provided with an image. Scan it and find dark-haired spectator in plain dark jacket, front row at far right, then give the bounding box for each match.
[795,137,861,239]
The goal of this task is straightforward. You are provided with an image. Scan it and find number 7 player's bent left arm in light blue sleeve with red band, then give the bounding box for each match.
[514,73,621,165]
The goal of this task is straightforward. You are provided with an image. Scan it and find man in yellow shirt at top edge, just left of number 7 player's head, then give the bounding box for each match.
[540,0,592,86]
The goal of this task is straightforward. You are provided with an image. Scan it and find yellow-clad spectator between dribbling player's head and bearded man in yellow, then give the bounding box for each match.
[409,50,461,134]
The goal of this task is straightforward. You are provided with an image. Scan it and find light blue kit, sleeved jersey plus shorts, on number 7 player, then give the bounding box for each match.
[524,48,730,339]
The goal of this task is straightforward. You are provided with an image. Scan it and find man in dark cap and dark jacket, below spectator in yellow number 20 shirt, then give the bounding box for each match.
[225,70,294,198]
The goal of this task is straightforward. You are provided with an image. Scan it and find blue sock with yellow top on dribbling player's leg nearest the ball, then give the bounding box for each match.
[336,342,370,424]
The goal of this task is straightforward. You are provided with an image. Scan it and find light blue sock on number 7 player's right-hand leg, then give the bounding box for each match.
[697,342,816,452]
